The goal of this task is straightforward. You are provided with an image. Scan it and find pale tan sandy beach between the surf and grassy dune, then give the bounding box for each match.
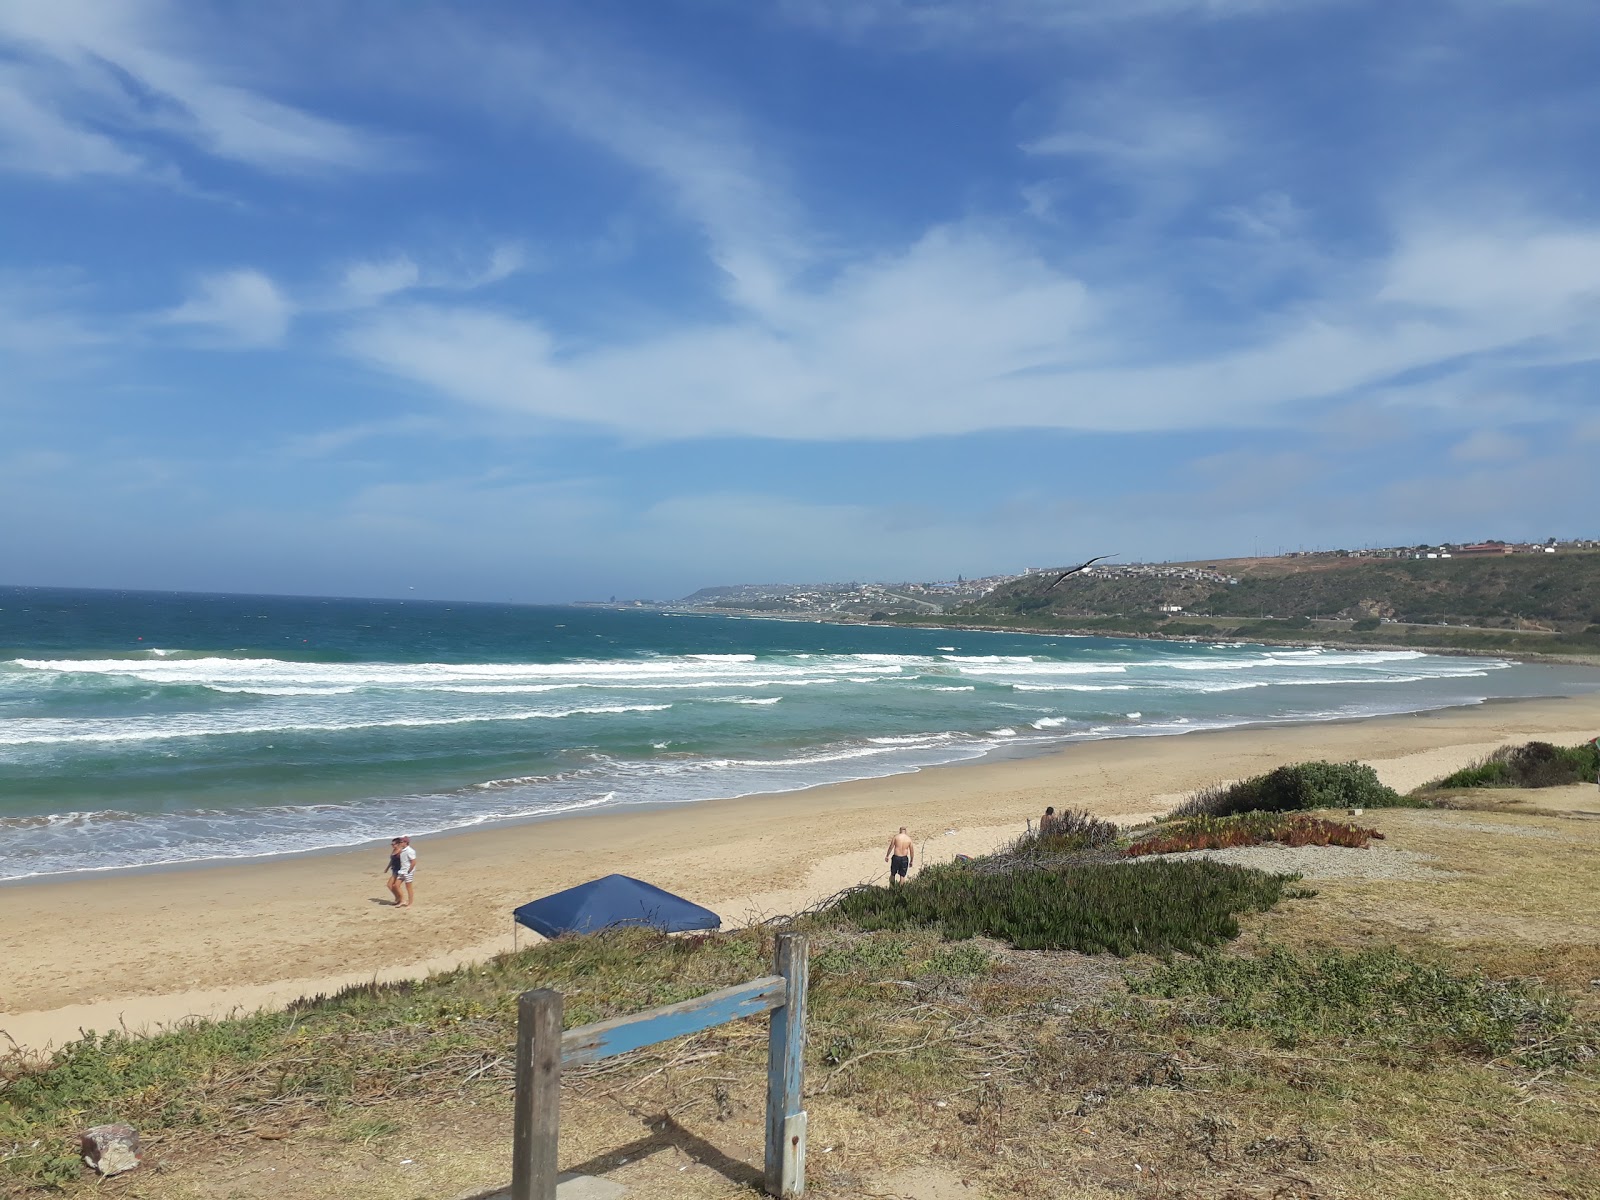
[0,696,1600,1048]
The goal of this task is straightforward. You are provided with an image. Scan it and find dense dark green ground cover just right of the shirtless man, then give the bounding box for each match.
[838,861,1286,957]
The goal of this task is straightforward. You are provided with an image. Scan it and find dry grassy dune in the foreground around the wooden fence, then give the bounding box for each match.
[9,773,1600,1200]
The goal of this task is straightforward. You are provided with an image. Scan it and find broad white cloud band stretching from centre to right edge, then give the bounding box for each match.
[344,217,1600,438]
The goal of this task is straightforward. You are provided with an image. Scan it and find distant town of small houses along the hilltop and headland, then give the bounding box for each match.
[578,538,1600,618]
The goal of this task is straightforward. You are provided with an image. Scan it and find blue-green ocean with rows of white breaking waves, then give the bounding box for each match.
[0,587,1600,878]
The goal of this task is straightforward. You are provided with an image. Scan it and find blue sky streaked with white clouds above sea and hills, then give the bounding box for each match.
[0,0,1600,602]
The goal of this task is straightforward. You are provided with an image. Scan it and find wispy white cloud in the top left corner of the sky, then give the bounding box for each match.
[0,0,390,179]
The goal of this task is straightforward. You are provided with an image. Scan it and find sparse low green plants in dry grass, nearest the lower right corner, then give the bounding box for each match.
[1130,946,1597,1069]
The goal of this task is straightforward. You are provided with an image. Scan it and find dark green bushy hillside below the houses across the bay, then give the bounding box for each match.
[957,552,1600,632]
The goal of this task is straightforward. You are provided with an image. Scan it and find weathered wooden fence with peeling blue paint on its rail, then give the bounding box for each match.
[510,933,806,1200]
